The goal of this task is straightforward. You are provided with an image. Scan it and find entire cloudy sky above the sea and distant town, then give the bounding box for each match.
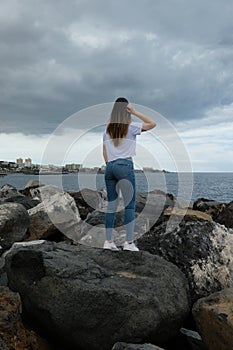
[0,0,233,171]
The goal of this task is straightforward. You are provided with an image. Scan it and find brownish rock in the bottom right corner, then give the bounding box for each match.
[192,289,233,350]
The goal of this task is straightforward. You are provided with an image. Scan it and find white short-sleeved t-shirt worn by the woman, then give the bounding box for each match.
[103,122,142,162]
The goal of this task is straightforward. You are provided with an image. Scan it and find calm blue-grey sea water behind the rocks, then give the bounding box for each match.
[0,173,233,203]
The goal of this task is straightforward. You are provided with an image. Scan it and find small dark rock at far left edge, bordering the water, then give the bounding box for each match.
[0,184,39,209]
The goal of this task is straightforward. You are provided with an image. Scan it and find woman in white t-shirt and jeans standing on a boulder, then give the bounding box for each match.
[103,97,156,251]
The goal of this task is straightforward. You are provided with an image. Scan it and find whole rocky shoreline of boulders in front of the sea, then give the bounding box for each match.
[0,181,233,350]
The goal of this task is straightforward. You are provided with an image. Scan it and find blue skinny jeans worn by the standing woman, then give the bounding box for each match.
[105,158,136,241]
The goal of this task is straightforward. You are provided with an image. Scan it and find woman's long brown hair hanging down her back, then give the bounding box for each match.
[106,97,131,147]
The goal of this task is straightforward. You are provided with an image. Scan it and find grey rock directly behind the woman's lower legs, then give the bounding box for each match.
[79,210,149,248]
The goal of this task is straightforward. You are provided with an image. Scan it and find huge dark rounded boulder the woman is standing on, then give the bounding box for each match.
[6,242,190,350]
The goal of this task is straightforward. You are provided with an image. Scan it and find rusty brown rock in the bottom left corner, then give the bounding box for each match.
[0,286,49,350]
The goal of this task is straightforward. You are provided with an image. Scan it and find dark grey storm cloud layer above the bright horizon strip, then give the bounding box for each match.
[0,0,233,134]
